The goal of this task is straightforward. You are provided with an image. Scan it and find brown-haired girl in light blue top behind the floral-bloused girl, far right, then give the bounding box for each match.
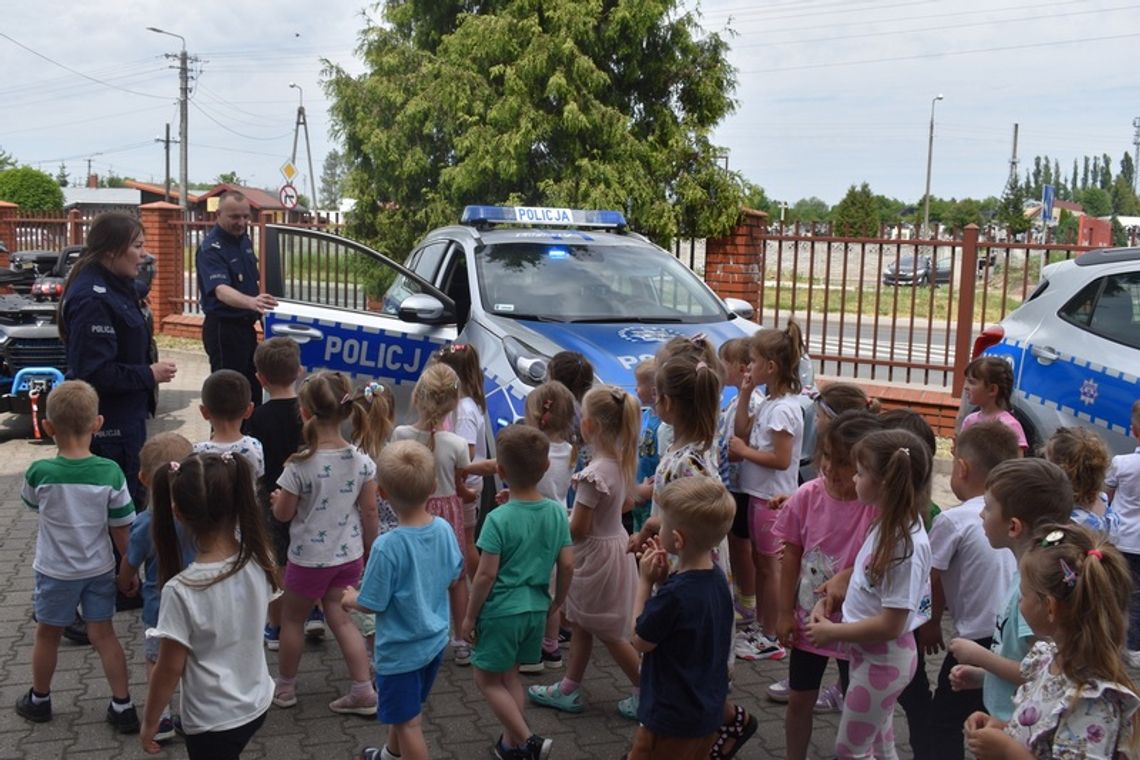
[1045,427,1121,542]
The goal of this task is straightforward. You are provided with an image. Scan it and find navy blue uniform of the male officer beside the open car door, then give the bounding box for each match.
[196,224,261,404]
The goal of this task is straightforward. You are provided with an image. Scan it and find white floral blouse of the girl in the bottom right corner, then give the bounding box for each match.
[1005,641,1140,760]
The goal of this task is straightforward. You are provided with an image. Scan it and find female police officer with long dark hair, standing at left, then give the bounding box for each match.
[59,213,177,509]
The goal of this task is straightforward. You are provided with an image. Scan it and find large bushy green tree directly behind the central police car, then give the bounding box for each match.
[325,0,743,258]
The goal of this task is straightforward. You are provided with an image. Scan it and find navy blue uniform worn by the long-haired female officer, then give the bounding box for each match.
[63,264,156,509]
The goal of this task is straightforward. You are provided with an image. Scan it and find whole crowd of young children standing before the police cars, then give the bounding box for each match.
[17,322,1140,760]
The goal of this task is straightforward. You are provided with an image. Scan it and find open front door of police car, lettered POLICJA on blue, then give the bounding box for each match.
[263,224,456,422]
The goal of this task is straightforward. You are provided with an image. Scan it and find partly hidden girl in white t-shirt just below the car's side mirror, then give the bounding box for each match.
[435,343,487,575]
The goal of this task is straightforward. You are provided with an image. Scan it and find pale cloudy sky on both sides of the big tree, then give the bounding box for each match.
[0,0,1140,204]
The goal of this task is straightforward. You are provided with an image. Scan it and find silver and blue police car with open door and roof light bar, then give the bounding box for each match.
[263,206,812,451]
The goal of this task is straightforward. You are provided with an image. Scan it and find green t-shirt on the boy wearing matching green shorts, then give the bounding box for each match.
[477,499,571,619]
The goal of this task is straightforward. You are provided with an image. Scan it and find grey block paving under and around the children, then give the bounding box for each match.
[0,352,953,760]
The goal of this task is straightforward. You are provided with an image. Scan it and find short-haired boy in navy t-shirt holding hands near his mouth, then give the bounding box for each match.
[626,477,734,760]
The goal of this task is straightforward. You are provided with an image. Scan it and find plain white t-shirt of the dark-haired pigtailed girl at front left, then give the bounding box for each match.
[147,556,274,734]
